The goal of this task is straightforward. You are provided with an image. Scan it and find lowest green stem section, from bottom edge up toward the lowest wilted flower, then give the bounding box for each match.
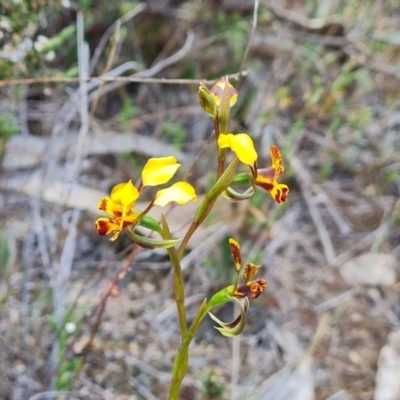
[168,300,208,400]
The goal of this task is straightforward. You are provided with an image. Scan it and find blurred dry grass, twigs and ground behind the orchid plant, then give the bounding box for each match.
[0,0,400,400]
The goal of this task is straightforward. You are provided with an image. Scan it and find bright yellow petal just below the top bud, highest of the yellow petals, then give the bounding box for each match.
[218,133,257,167]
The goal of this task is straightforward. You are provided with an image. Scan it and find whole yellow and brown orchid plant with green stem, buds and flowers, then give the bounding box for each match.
[95,77,289,400]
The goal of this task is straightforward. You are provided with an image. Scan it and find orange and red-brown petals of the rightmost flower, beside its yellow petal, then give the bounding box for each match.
[254,146,289,204]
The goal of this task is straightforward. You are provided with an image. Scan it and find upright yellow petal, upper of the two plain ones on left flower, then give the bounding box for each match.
[142,156,181,186]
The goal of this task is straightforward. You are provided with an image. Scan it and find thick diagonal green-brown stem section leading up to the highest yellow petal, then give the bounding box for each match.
[178,157,239,260]
